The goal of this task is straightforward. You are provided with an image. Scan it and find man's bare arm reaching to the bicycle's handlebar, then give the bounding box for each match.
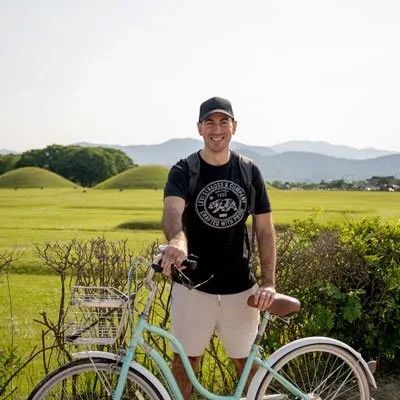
[161,196,188,276]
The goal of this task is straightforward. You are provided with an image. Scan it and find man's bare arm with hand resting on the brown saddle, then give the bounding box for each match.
[253,212,276,310]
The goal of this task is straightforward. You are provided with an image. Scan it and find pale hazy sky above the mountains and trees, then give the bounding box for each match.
[0,0,400,151]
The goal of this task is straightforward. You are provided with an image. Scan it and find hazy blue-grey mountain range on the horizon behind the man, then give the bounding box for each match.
[78,138,400,182]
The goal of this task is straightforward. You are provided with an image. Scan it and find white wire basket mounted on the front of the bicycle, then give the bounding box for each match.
[65,286,132,345]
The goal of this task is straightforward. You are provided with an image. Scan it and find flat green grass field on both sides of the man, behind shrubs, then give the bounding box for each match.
[0,188,400,273]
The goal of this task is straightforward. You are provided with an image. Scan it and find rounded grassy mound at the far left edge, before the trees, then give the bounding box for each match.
[0,167,78,189]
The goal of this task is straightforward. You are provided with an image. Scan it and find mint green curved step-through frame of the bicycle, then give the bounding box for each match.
[112,268,309,400]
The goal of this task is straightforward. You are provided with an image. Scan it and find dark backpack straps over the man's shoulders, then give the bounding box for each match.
[186,151,256,258]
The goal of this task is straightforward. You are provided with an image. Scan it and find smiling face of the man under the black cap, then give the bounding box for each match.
[197,112,236,152]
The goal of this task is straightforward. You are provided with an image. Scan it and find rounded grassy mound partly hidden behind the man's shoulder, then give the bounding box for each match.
[95,165,168,189]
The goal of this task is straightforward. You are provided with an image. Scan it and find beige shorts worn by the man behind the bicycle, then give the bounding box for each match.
[171,283,260,358]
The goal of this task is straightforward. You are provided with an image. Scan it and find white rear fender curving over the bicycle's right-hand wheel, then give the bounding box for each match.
[247,336,377,399]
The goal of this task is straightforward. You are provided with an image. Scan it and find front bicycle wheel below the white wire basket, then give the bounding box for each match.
[28,358,163,400]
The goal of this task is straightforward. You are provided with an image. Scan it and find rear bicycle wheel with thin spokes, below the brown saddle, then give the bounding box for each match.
[256,343,370,400]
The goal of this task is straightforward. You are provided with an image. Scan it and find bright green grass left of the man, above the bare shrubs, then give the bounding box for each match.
[0,189,162,273]
